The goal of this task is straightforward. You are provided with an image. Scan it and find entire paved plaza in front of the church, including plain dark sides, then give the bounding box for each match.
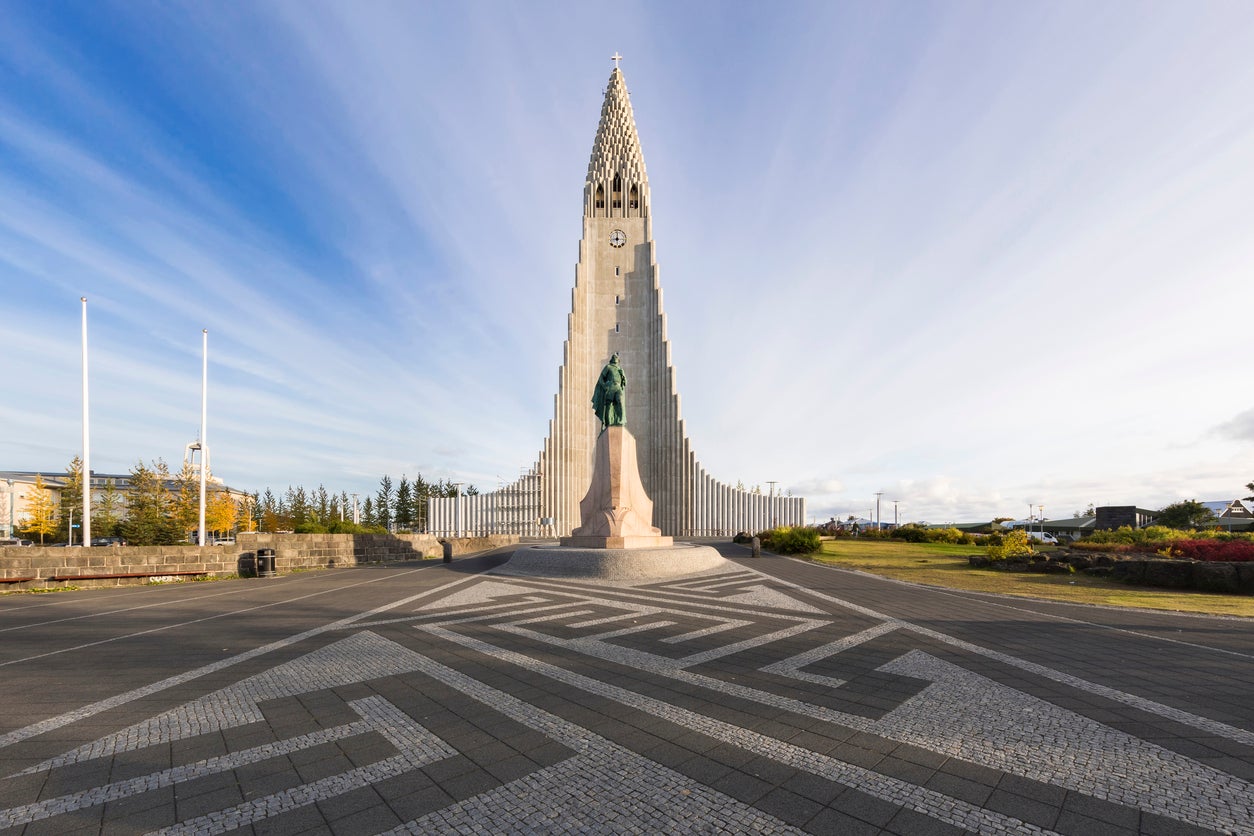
[0,544,1254,836]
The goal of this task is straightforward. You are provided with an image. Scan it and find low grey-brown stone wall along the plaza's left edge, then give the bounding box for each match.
[0,534,518,593]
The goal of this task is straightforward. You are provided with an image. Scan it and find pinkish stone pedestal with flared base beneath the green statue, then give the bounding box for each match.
[561,426,673,549]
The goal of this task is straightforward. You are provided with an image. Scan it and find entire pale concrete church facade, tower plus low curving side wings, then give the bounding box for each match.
[429,62,805,536]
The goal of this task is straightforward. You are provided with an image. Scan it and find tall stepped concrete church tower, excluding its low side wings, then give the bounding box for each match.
[542,68,687,534]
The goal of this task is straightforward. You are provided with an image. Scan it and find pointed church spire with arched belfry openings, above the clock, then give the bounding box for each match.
[583,61,648,218]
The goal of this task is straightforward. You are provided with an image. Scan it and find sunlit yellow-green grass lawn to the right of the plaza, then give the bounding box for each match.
[809,540,1254,617]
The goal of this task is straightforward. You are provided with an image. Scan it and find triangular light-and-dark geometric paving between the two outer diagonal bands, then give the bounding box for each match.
[0,556,1254,835]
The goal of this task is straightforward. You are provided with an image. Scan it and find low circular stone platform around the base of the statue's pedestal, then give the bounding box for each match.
[494,543,732,580]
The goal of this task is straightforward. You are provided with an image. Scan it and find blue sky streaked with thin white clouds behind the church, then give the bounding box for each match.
[0,0,1254,521]
